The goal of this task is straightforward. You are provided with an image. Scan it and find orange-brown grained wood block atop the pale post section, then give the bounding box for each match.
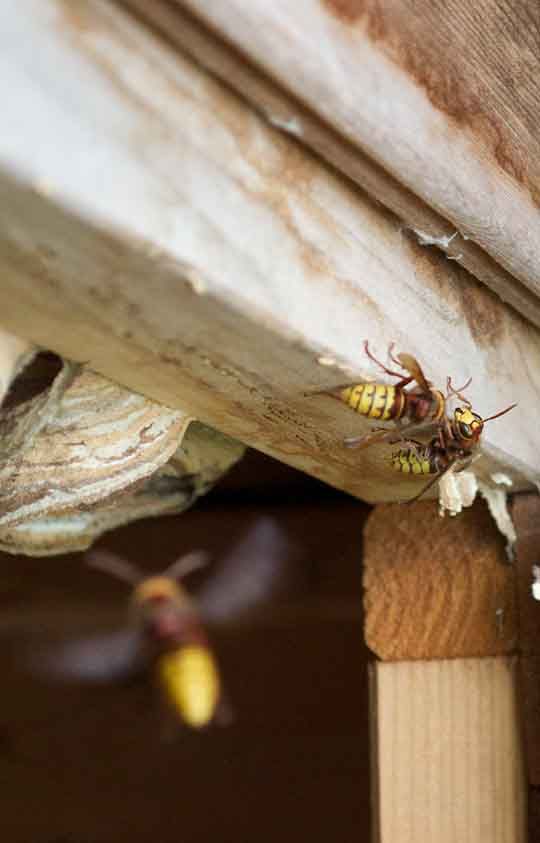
[364,501,518,660]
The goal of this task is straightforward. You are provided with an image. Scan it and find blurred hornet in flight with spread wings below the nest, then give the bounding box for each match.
[24,517,292,729]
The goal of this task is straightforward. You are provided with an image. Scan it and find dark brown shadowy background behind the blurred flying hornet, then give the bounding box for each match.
[0,452,369,843]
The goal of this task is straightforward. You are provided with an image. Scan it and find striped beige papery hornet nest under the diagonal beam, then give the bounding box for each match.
[0,340,244,556]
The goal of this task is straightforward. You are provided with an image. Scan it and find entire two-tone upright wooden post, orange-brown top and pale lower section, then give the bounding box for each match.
[364,503,526,843]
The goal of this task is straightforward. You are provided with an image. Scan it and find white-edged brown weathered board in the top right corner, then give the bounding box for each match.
[177,0,540,306]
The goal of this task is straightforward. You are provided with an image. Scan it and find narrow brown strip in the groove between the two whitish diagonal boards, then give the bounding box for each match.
[122,0,540,325]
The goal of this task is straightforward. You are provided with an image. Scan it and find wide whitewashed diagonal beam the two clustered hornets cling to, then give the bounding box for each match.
[0,0,540,501]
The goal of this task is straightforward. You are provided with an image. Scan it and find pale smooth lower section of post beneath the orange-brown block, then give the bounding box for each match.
[372,658,527,843]
